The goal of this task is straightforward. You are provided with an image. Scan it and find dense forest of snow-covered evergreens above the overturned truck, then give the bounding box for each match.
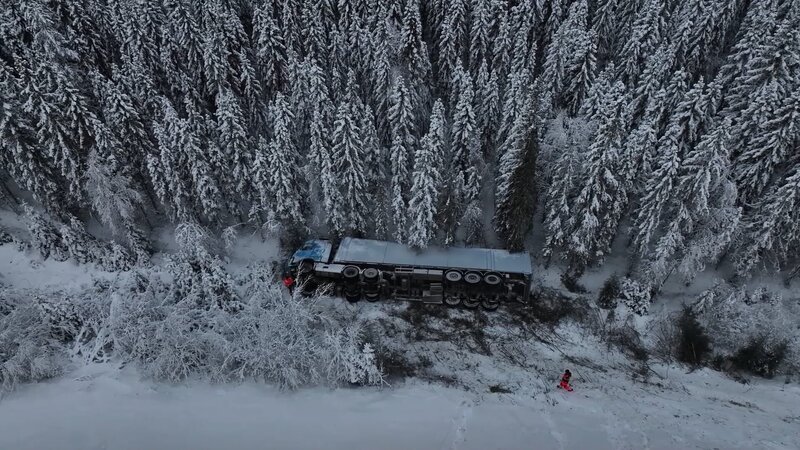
[0,0,800,283]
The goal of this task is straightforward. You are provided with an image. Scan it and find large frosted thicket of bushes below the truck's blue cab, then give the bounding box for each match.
[108,266,382,389]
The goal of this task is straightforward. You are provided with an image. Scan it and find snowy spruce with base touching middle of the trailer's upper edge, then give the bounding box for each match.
[408,100,445,248]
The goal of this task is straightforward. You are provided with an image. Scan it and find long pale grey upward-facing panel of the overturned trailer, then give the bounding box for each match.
[333,238,533,275]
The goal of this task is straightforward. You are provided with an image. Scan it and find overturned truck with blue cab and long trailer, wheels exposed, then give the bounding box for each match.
[284,238,532,311]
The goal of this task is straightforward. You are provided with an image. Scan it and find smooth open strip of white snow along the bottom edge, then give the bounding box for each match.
[0,365,800,450]
